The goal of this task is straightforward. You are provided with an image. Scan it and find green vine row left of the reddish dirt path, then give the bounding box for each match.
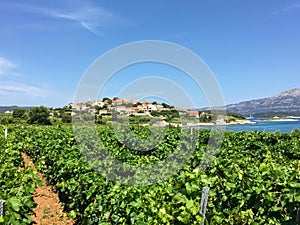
[0,126,41,224]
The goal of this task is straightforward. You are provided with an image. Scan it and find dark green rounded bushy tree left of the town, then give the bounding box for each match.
[27,106,51,125]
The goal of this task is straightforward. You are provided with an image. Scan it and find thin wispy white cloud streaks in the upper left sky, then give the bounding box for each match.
[1,1,128,36]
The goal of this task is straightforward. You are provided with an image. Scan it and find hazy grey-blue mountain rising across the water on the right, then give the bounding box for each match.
[226,88,300,116]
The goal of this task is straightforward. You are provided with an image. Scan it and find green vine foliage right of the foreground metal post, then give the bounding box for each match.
[208,132,300,224]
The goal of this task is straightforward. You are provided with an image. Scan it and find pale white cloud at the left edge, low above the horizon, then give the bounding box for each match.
[0,56,47,97]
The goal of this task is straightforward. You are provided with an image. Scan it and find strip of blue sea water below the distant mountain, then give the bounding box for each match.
[200,121,300,133]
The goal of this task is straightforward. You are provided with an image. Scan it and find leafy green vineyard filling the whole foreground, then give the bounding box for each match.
[0,126,300,225]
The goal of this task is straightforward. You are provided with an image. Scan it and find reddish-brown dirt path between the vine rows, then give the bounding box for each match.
[22,153,74,225]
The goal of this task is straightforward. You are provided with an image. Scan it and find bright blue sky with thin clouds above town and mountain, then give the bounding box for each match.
[0,0,300,107]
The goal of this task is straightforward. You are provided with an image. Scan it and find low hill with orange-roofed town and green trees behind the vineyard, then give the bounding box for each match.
[0,97,249,126]
